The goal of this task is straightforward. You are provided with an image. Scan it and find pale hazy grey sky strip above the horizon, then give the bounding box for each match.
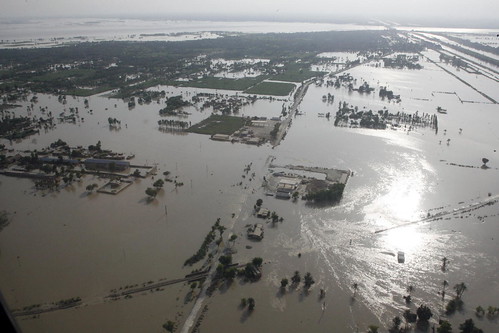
[0,0,499,23]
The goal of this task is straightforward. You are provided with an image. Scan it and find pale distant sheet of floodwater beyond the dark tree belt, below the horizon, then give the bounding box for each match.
[0,18,386,48]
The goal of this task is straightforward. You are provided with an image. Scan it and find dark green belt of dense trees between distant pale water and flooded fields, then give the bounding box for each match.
[0,30,423,95]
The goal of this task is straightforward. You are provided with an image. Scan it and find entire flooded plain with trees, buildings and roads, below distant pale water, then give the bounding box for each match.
[0,22,499,332]
